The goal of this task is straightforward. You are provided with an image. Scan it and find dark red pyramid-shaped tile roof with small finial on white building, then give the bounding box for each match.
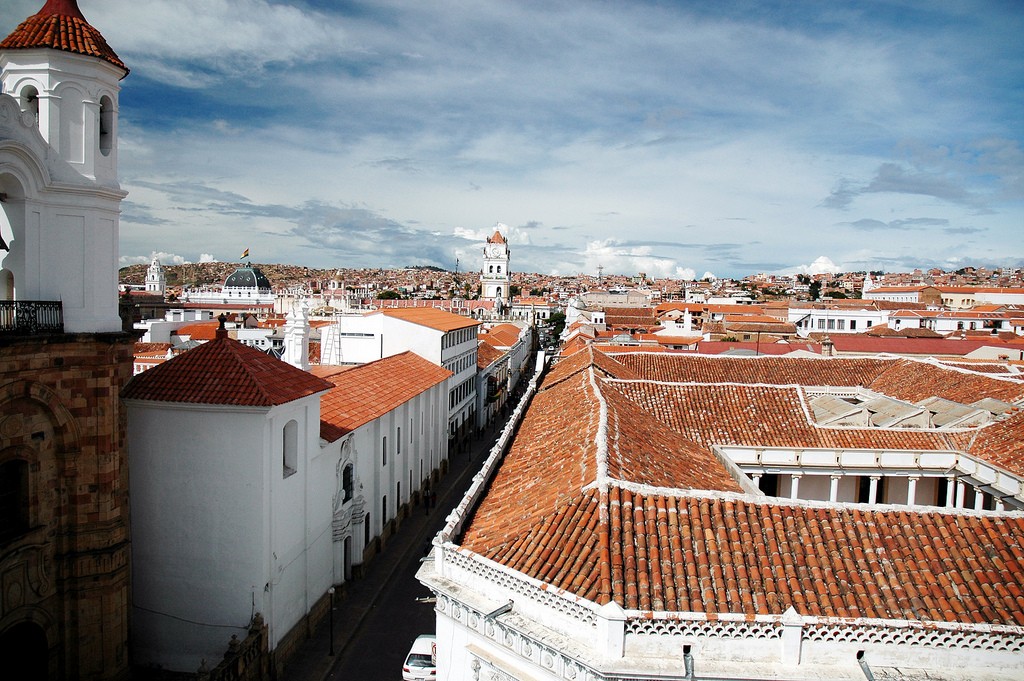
[122,338,332,407]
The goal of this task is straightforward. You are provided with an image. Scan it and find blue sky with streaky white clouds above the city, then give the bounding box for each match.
[0,0,1024,279]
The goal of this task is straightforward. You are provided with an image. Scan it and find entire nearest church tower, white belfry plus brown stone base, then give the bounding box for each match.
[0,0,132,681]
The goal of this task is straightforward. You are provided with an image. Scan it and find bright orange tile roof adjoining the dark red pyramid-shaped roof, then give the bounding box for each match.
[317,350,453,442]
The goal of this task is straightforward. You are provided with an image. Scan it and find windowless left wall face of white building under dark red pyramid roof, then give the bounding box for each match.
[128,400,270,672]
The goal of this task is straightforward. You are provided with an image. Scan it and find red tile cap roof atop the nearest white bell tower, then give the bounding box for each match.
[0,0,128,75]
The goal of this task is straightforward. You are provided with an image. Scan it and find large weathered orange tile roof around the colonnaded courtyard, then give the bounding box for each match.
[462,347,1024,626]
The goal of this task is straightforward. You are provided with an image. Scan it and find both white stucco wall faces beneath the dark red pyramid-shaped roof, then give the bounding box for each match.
[127,395,333,672]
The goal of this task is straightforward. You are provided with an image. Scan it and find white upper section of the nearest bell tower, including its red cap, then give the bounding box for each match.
[0,0,128,333]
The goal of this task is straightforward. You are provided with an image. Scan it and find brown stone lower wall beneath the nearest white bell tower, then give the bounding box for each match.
[0,334,132,681]
